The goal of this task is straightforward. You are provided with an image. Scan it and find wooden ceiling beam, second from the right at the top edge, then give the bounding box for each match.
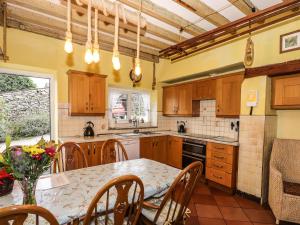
[173,0,230,27]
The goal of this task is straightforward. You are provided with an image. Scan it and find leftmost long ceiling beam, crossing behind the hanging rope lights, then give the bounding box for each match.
[7,0,168,49]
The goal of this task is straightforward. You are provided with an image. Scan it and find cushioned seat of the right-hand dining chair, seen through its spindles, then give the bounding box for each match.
[142,196,180,225]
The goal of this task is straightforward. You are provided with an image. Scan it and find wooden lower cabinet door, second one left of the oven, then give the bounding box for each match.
[153,136,167,164]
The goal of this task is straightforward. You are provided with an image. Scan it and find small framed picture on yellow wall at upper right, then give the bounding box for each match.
[280,30,300,53]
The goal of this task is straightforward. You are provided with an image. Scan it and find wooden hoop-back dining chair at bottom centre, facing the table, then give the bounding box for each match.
[83,175,144,225]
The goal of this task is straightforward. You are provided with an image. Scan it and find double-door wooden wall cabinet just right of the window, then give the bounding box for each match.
[163,84,195,116]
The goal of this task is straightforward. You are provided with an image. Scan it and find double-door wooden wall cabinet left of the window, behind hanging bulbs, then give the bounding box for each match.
[68,70,106,116]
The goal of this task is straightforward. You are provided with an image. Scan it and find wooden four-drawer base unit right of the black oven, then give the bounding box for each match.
[206,142,238,189]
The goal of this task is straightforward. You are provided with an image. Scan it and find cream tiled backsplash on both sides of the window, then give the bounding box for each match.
[58,100,238,140]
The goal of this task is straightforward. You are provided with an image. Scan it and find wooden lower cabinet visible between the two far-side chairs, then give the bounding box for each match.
[78,141,104,166]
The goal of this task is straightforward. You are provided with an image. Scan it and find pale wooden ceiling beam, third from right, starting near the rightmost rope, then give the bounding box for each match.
[119,0,205,36]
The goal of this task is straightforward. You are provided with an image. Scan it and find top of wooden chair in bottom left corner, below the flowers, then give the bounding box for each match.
[0,205,59,225]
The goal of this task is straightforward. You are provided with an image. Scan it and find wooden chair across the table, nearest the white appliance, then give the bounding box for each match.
[101,139,128,164]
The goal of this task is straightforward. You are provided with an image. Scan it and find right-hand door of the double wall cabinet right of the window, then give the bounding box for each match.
[176,84,193,115]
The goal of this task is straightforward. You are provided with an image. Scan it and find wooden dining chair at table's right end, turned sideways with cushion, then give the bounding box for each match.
[140,162,203,225]
